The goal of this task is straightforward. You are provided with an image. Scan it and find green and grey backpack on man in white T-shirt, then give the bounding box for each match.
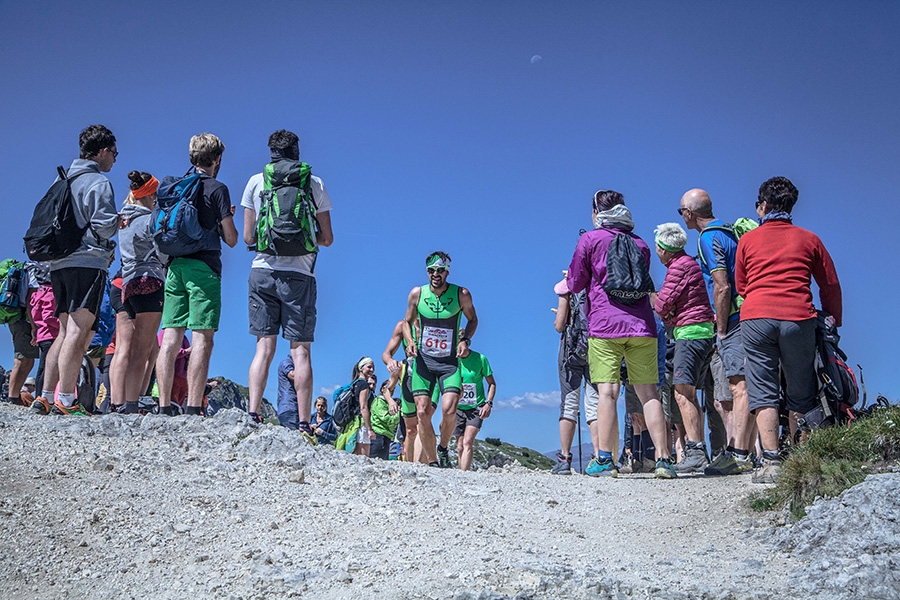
[256,159,319,256]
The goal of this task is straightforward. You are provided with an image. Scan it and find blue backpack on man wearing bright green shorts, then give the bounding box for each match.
[152,169,220,256]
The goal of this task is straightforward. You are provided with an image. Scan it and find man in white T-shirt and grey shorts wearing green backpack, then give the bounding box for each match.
[241,129,334,442]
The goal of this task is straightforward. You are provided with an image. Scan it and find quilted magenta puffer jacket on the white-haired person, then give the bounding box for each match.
[653,250,713,327]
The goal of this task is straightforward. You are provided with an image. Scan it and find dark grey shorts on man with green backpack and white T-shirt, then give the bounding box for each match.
[247,269,316,342]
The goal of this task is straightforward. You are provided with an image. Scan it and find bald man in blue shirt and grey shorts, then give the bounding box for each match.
[678,188,753,475]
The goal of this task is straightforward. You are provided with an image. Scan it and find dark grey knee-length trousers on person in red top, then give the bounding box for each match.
[741,318,818,413]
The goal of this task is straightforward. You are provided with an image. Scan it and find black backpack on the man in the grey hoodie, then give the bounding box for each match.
[24,166,90,261]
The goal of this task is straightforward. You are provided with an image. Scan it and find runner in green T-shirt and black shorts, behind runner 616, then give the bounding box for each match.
[453,350,497,471]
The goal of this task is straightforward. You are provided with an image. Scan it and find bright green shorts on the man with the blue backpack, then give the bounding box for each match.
[161,257,222,331]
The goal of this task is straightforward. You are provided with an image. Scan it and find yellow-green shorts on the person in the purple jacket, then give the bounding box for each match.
[588,337,659,385]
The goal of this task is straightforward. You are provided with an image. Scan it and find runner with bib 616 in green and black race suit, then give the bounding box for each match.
[403,251,478,468]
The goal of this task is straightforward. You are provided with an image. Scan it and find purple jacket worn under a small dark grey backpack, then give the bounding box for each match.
[566,228,656,338]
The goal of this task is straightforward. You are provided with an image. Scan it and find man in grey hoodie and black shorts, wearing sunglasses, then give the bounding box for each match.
[33,125,119,415]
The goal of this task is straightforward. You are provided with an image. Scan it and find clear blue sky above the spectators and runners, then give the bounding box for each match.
[0,1,900,451]
